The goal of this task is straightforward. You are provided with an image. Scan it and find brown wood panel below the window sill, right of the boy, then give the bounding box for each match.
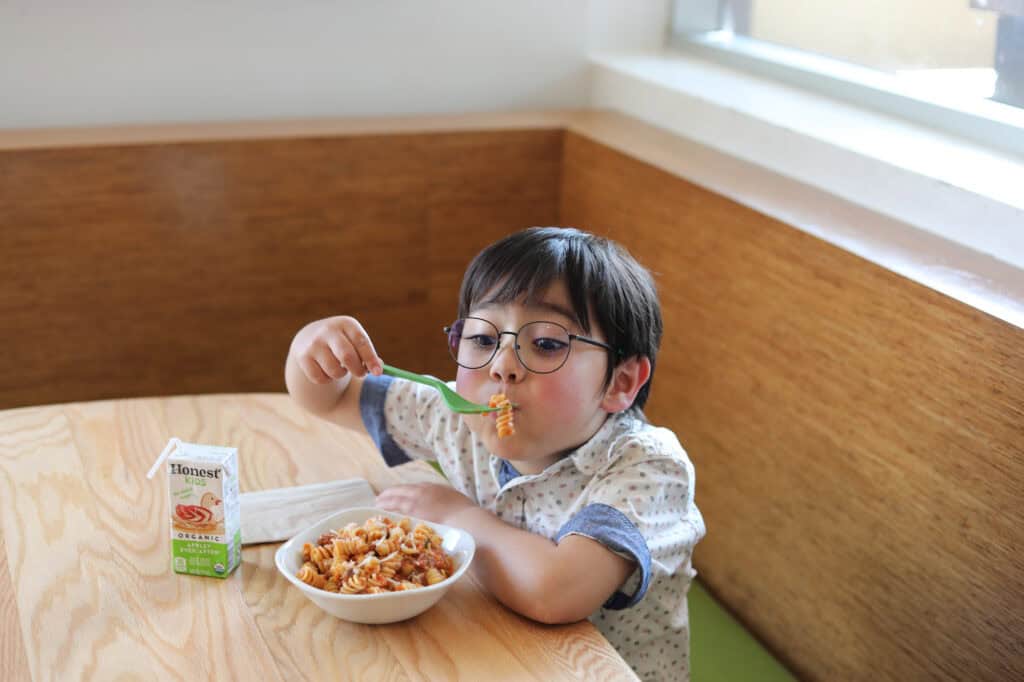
[561,134,1024,680]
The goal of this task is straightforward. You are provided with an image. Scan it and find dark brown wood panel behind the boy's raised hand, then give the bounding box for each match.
[0,130,562,409]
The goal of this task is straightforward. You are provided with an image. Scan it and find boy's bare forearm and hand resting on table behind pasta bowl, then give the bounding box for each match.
[378,483,636,624]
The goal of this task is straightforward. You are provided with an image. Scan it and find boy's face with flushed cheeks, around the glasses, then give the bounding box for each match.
[456,282,609,474]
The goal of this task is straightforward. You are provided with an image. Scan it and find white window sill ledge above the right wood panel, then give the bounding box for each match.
[591,51,1024,327]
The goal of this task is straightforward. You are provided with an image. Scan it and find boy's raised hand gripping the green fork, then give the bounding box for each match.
[291,315,384,384]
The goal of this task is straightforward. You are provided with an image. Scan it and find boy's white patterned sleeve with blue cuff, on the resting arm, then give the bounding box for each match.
[556,439,705,609]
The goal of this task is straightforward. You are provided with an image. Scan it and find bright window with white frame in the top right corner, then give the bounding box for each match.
[673,0,1024,155]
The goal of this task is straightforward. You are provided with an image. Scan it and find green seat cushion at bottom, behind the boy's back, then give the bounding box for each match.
[687,580,797,682]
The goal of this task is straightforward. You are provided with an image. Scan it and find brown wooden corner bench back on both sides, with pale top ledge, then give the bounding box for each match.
[0,113,1024,682]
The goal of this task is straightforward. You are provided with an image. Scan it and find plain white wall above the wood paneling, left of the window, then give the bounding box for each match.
[0,0,669,128]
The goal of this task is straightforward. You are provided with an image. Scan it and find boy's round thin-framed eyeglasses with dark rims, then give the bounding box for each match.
[444,317,615,374]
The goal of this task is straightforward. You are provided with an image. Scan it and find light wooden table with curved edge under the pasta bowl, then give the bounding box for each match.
[0,394,635,682]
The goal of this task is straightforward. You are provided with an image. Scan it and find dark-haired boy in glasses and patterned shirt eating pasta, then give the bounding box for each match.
[286,227,705,680]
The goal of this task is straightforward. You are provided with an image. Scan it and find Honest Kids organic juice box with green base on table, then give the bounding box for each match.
[167,441,242,578]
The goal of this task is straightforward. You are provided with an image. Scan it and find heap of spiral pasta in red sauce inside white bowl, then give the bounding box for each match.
[296,516,455,594]
